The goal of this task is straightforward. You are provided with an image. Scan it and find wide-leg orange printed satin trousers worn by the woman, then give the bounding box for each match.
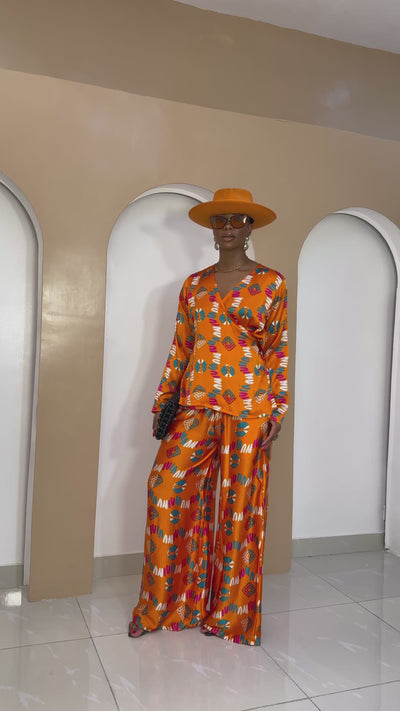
[132,408,269,645]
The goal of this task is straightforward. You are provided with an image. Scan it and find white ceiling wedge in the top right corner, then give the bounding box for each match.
[176,0,400,54]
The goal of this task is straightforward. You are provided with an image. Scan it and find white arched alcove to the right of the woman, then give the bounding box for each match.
[293,208,400,555]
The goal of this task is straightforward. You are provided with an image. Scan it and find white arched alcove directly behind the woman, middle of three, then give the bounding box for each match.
[95,185,252,575]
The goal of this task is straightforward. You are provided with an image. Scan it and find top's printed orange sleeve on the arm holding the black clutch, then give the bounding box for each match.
[152,282,194,412]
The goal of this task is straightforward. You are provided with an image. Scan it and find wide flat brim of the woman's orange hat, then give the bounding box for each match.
[189,200,276,229]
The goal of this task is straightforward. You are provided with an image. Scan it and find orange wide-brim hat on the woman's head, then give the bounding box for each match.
[189,188,276,229]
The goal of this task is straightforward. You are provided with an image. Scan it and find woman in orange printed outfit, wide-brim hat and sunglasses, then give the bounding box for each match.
[129,189,288,645]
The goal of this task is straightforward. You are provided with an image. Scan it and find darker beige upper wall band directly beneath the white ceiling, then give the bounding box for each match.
[0,0,400,139]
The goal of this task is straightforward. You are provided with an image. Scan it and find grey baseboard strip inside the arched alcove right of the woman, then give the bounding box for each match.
[292,533,385,558]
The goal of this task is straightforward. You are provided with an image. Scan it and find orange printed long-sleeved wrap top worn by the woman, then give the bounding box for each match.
[152,265,288,422]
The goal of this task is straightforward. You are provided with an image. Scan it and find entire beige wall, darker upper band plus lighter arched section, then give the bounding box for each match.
[0,0,400,600]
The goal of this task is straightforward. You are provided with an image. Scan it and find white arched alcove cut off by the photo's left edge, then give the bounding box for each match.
[0,173,42,587]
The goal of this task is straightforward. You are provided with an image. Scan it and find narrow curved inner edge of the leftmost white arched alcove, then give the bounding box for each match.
[0,172,43,585]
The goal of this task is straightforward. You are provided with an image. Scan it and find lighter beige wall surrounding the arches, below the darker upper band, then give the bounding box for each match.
[0,71,400,599]
